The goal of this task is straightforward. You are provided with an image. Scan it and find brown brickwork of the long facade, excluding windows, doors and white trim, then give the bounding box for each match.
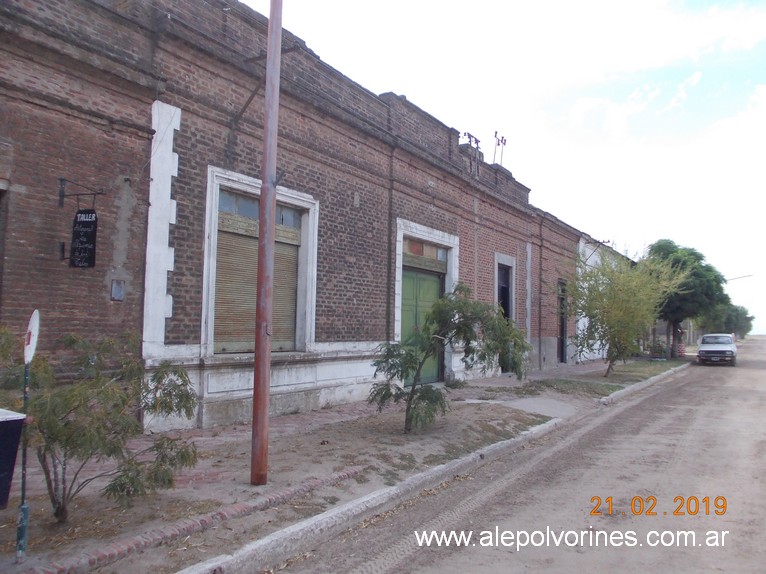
[0,0,578,378]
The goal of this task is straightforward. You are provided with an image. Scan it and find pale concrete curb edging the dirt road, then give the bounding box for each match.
[176,364,689,574]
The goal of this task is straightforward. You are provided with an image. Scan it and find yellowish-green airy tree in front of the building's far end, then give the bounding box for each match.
[569,251,685,376]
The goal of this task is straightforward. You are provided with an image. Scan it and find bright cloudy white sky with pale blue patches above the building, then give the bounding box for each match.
[245,0,766,334]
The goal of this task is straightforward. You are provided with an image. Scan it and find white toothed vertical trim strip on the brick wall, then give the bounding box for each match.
[142,101,181,359]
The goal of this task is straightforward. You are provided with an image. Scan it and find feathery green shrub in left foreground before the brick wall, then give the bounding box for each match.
[0,336,197,522]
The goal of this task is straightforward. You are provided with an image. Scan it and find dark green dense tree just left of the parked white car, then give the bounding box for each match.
[649,239,730,357]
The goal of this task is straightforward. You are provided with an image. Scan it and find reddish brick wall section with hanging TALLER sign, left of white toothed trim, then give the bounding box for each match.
[0,2,151,351]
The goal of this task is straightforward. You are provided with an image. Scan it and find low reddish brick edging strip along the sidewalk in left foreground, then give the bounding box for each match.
[15,466,362,574]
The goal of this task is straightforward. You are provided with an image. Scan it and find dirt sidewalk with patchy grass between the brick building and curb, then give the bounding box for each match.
[0,362,677,574]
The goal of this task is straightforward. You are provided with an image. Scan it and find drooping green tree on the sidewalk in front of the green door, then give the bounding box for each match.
[368,284,531,433]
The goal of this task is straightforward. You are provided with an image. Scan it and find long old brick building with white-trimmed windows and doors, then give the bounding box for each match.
[0,0,589,427]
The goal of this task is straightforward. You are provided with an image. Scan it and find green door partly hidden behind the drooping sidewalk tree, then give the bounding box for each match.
[402,269,442,385]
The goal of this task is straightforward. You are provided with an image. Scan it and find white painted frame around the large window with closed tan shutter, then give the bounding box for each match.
[200,166,319,357]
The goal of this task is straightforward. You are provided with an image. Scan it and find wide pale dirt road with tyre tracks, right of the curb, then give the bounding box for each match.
[283,339,766,574]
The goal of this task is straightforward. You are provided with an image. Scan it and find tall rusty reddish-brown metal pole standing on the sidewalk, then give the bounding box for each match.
[250,0,282,485]
